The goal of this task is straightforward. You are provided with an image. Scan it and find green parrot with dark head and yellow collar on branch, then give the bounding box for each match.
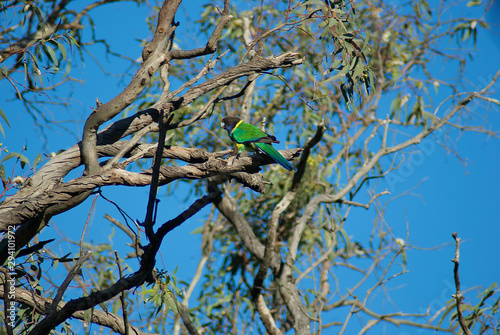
[220,116,293,171]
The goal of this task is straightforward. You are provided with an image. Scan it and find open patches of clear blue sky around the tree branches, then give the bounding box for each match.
[0,1,500,334]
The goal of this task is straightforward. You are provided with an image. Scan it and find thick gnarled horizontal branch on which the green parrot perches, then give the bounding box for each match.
[0,149,302,262]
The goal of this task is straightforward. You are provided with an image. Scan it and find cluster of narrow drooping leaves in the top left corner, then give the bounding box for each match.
[0,0,140,136]
